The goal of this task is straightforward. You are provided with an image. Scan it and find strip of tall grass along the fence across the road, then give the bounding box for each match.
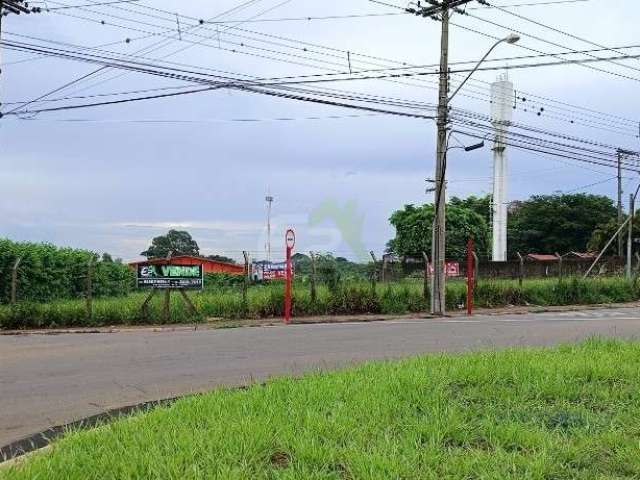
[0,278,640,329]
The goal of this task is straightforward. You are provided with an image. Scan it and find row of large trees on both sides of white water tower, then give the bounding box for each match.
[387,193,640,259]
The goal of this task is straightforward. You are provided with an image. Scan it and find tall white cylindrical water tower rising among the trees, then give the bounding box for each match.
[491,73,514,262]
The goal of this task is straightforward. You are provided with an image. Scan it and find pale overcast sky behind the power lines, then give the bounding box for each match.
[0,0,640,259]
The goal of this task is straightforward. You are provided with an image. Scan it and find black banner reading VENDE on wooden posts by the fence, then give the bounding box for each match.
[137,264,204,290]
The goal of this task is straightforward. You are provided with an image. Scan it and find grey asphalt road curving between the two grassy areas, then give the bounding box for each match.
[0,308,640,446]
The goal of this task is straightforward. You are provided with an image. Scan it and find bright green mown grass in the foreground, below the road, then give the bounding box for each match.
[5,339,640,480]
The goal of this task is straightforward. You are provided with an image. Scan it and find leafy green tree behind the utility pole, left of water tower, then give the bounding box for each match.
[387,203,489,259]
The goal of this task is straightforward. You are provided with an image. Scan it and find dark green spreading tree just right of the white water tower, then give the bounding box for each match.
[508,193,616,255]
